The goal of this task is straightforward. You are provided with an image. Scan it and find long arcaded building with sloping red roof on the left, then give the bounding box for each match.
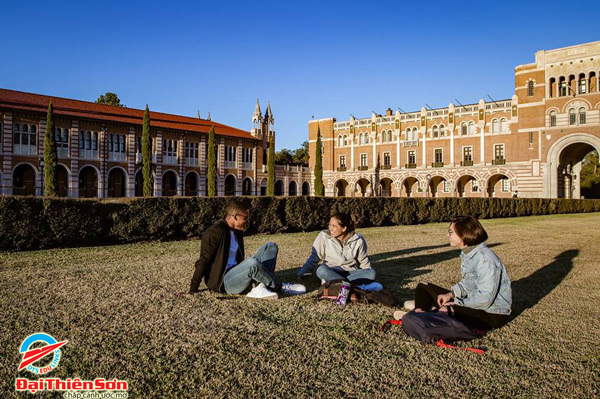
[0,89,310,198]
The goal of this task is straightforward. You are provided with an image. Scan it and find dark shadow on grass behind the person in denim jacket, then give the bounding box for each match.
[511,249,579,320]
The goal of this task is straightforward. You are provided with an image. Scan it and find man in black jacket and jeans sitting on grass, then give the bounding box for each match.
[189,200,306,299]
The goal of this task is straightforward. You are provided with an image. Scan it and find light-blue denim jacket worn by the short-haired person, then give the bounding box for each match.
[452,242,512,315]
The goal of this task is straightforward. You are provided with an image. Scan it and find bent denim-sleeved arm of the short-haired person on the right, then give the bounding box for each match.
[452,259,502,310]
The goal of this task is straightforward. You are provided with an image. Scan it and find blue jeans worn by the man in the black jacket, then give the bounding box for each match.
[223,242,281,294]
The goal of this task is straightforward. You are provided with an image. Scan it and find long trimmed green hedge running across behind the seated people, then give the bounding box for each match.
[0,197,600,251]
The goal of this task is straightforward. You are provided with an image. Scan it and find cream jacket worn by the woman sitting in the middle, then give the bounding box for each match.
[298,230,371,276]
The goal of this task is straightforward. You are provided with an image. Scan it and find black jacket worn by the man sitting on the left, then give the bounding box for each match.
[190,220,244,294]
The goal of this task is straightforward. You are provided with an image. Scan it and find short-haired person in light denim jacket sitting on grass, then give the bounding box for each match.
[394,216,512,331]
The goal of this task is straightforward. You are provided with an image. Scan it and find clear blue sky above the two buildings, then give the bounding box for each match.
[0,0,600,149]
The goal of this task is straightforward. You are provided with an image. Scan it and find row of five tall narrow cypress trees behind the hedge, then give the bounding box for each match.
[44,100,324,197]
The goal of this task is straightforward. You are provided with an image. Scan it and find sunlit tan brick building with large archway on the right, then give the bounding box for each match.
[308,42,600,198]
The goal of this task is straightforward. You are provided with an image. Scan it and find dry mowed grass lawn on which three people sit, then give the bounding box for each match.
[0,214,600,398]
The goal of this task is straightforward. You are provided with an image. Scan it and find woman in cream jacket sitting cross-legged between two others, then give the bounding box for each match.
[298,212,379,289]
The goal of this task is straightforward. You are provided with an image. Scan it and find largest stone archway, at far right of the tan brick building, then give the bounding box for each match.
[544,133,600,198]
